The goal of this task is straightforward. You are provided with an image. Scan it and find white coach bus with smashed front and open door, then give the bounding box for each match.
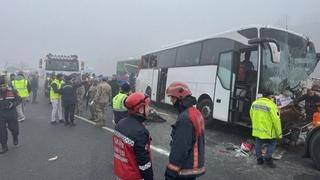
[136,26,317,126]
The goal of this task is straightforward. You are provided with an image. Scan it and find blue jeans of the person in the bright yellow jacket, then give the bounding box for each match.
[255,138,277,158]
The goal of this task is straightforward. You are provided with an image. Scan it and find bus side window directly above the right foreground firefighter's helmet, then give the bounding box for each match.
[176,43,201,66]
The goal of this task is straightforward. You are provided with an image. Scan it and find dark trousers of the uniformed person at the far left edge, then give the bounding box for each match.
[0,117,19,145]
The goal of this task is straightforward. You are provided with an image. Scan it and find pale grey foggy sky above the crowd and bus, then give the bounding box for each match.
[0,0,320,75]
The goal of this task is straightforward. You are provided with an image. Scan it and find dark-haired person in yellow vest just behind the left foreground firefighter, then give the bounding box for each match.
[112,83,131,124]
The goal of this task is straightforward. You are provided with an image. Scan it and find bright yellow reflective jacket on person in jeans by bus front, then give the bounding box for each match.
[250,97,282,139]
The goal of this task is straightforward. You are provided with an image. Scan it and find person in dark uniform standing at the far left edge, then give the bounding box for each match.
[0,76,21,154]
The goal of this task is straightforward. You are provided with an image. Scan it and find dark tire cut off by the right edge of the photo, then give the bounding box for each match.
[309,130,320,170]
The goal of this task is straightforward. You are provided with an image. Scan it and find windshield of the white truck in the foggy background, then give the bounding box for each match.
[45,60,79,71]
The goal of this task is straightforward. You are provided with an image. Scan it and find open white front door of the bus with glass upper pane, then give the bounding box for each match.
[213,51,234,122]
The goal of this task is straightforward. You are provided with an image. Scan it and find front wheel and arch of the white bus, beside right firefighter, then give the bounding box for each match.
[197,94,213,123]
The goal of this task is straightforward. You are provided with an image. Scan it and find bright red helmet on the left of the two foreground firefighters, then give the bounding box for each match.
[124,92,150,114]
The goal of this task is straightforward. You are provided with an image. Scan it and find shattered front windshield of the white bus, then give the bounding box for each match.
[260,28,317,94]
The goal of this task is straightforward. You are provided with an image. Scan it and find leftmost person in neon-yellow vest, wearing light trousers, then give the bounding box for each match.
[12,72,31,122]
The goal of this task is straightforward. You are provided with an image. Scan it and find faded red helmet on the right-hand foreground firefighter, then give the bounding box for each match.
[166,81,192,99]
